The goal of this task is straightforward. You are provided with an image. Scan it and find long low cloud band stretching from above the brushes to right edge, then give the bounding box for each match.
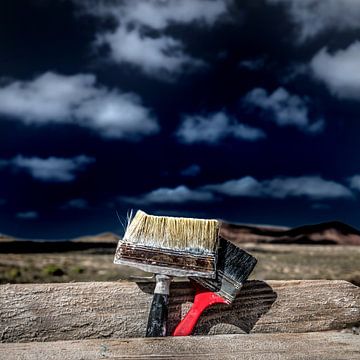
[119,176,352,205]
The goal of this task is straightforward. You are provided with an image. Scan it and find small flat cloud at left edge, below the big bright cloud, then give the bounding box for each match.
[0,155,95,182]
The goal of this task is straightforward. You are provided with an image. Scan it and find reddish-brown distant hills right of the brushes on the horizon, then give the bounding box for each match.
[221,221,360,245]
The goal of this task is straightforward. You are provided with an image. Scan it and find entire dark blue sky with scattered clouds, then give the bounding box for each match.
[0,0,360,239]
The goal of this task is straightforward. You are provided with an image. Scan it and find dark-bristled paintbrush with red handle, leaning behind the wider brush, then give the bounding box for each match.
[173,238,257,336]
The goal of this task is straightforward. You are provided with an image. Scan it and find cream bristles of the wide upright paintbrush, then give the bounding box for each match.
[123,210,219,254]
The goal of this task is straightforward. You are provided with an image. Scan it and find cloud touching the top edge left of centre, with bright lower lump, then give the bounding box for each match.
[76,0,227,78]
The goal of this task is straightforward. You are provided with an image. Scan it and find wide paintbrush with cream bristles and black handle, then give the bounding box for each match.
[114,210,219,337]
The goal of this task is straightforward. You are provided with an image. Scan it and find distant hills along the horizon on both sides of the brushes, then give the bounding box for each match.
[0,221,360,254]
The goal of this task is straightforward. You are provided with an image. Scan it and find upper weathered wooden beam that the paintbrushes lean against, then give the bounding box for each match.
[0,280,360,342]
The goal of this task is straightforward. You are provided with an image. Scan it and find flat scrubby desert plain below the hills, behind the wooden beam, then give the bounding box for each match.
[0,243,360,285]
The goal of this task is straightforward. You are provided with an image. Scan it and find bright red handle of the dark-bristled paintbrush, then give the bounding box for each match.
[173,284,228,336]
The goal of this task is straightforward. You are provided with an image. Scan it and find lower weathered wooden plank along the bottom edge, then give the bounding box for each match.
[0,332,360,360]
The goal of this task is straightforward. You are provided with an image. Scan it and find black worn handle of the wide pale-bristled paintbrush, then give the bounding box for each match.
[146,275,171,337]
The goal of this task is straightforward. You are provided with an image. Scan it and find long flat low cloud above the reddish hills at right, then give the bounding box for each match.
[203,176,353,200]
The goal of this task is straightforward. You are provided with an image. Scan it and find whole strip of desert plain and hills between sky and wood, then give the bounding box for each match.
[0,222,360,285]
